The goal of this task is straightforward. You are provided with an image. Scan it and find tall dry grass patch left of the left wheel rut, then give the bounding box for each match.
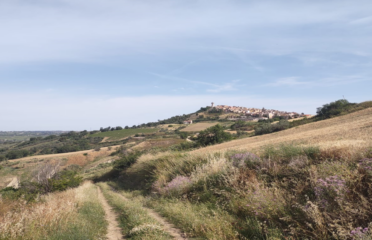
[0,183,107,240]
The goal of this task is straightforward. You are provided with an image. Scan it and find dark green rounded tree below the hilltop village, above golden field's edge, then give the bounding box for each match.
[196,124,232,146]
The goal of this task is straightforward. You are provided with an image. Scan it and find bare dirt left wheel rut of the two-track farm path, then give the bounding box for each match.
[97,186,124,240]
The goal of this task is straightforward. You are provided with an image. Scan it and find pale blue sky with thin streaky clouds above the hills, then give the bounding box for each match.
[0,0,372,131]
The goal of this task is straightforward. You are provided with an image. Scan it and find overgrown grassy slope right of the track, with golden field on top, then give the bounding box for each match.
[111,109,372,239]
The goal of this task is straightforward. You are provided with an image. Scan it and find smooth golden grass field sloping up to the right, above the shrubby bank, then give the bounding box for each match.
[193,108,372,153]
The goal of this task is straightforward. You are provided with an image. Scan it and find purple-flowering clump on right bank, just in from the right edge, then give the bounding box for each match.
[314,176,347,208]
